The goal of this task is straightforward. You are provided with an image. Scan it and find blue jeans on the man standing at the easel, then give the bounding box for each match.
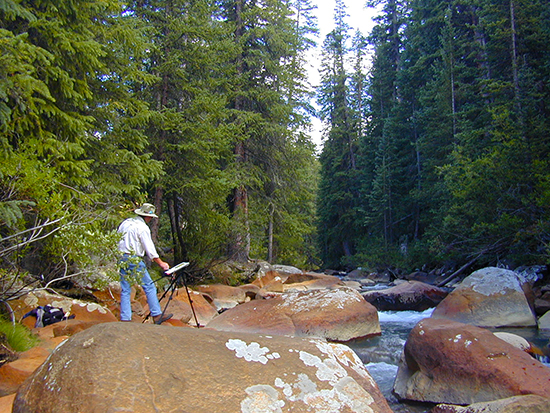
[120,255,162,321]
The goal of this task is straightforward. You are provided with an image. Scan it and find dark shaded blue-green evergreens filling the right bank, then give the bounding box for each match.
[319,0,550,269]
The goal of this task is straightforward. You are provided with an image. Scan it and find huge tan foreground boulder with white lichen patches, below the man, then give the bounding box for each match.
[13,323,391,413]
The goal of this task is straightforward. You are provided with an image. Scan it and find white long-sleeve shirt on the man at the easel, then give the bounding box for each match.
[118,216,159,260]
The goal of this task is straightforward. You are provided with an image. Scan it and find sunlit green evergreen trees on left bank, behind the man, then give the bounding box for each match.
[0,0,324,283]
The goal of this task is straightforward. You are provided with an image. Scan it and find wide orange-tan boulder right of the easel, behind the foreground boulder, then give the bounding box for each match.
[208,287,380,341]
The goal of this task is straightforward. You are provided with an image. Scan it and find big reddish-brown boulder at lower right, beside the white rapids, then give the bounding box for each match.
[394,318,550,405]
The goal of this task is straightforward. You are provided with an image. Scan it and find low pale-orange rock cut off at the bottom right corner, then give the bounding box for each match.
[430,394,550,413]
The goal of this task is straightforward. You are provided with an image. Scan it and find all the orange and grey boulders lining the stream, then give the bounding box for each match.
[0,264,550,413]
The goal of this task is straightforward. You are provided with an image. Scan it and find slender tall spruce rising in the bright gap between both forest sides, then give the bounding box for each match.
[318,1,360,266]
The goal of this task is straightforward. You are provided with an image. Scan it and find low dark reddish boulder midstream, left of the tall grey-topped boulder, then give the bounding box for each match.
[363,281,448,311]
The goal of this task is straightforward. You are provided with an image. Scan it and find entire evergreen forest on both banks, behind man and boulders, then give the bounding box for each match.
[0,0,550,292]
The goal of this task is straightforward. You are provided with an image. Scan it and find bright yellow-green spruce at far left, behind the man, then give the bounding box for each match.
[0,0,160,281]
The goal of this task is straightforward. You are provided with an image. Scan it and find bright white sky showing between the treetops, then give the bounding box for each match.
[308,0,377,150]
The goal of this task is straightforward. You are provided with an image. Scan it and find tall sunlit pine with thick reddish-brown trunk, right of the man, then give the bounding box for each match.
[223,0,316,261]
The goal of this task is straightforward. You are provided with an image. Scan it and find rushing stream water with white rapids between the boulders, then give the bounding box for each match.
[346,309,550,413]
